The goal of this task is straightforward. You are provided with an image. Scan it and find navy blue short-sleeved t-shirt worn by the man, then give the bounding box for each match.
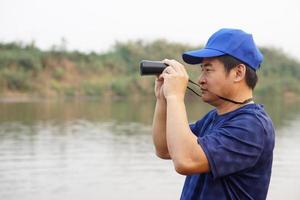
[180,104,275,200]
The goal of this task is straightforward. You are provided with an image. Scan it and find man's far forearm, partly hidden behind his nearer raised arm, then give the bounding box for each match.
[152,100,170,159]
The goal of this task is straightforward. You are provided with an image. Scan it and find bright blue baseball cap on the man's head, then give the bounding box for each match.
[182,28,263,70]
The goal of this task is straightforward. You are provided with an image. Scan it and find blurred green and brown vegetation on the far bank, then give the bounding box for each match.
[0,40,300,97]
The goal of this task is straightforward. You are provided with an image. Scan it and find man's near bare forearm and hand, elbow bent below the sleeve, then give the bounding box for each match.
[155,59,209,175]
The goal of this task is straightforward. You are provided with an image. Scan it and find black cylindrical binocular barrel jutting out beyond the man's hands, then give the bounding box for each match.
[140,60,168,76]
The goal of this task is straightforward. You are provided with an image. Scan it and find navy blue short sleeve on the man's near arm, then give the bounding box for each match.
[198,114,264,179]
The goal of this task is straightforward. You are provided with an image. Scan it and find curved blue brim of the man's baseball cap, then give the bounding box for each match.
[182,49,225,65]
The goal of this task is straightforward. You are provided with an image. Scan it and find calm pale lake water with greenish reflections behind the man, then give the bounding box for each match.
[0,97,300,200]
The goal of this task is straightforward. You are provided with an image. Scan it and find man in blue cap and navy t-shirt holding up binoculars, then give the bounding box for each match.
[153,29,274,200]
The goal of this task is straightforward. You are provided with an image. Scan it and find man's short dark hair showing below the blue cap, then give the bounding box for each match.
[217,55,258,90]
